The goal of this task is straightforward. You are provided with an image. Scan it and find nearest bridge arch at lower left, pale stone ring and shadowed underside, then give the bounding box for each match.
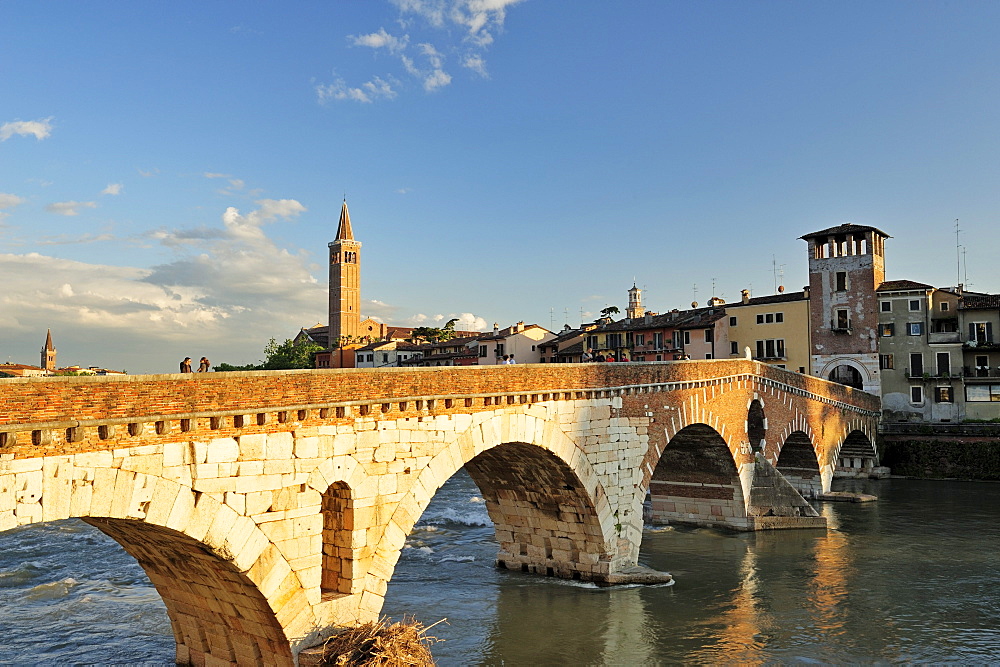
[0,465,304,665]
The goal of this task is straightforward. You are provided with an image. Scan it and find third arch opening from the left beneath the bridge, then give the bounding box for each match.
[649,424,748,530]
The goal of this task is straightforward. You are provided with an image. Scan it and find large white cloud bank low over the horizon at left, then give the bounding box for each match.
[0,199,327,372]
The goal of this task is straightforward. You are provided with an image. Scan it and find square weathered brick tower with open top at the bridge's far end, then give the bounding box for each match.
[801,223,890,394]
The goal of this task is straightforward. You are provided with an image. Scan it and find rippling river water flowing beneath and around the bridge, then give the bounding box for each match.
[0,473,1000,665]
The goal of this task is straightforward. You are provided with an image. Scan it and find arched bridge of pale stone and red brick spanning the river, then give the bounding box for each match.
[0,360,879,664]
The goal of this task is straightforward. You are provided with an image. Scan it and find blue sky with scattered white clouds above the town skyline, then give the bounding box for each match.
[0,0,1000,373]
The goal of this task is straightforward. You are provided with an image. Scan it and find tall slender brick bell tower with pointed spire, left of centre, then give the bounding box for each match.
[329,199,361,349]
